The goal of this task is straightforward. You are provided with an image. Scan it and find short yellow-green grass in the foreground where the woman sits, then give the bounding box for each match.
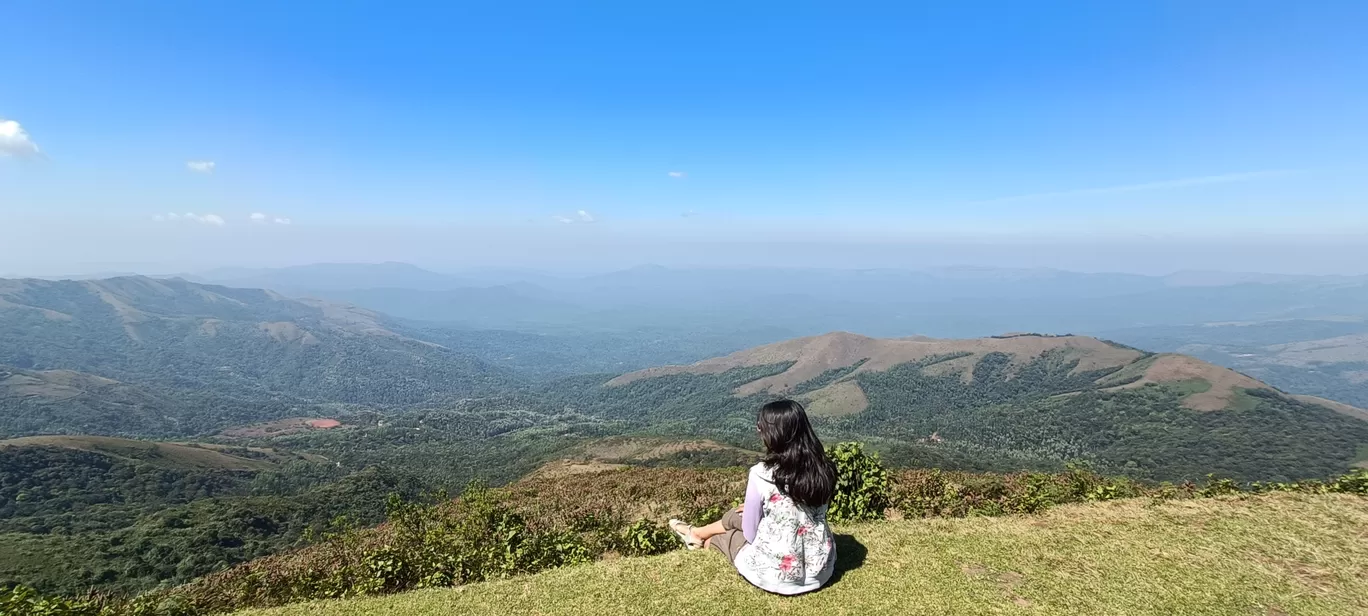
[239,494,1368,616]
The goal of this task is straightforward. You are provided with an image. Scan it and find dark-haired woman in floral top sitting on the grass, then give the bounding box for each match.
[670,400,836,594]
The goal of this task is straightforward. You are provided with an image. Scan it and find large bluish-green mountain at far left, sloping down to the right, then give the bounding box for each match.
[0,277,518,434]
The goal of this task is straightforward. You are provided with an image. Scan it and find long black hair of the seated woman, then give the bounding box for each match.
[755,400,836,506]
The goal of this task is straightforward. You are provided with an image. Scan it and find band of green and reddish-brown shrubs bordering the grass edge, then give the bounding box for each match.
[8,444,1368,616]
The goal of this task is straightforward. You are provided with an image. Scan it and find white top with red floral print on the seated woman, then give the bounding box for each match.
[736,463,836,594]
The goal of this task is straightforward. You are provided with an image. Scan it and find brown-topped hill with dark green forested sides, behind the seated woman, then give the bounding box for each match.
[590,333,1368,480]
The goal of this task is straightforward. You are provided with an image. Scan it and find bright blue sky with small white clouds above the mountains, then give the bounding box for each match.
[0,1,1368,272]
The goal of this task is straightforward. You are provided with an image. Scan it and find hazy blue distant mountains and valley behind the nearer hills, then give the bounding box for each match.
[173,263,1368,407]
